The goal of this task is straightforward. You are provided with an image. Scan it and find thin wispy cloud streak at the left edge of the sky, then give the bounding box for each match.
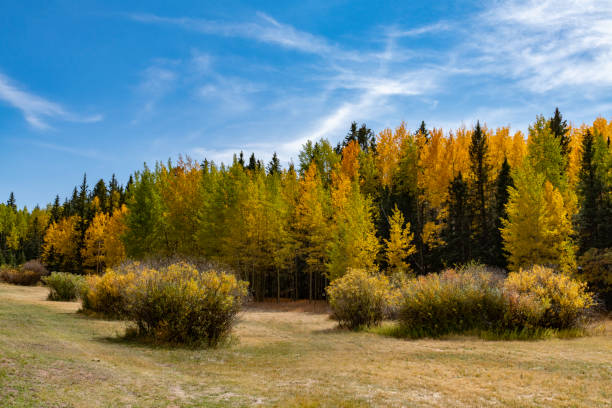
[0,73,102,129]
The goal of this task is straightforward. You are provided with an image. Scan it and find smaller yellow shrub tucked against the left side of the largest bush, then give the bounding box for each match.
[80,269,136,318]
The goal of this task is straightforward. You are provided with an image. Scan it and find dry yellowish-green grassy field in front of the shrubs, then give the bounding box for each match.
[0,284,612,407]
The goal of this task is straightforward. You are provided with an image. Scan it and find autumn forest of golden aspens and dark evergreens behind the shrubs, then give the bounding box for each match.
[0,109,612,302]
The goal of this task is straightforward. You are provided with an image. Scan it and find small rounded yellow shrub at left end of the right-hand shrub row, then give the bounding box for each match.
[327,269,392,329]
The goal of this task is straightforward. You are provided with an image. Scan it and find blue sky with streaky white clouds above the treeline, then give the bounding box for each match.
[0,0,612,207]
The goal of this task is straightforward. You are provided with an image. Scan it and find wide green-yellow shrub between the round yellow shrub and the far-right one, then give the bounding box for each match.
[398,267,505,337]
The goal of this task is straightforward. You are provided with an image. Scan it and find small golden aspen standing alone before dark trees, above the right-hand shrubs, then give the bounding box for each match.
[384,205,416,275]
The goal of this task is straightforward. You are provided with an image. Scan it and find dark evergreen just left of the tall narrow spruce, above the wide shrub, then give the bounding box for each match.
[442,172,472,265]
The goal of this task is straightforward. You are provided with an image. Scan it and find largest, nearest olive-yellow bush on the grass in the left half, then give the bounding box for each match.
[127,263,247,346]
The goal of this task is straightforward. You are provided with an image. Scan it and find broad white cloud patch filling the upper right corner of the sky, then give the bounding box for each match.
[466,0,612,93]
